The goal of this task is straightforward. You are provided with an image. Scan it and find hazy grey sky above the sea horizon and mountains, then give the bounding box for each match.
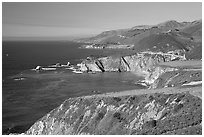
[2,2,202,37]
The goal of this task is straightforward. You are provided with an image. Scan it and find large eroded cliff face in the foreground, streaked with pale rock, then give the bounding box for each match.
[25,92,202,135]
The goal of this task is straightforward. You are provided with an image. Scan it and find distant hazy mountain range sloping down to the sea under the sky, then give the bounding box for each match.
[77,20,202,59]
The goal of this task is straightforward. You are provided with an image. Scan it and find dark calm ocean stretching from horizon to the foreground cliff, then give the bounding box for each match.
[2,41,144,134]
